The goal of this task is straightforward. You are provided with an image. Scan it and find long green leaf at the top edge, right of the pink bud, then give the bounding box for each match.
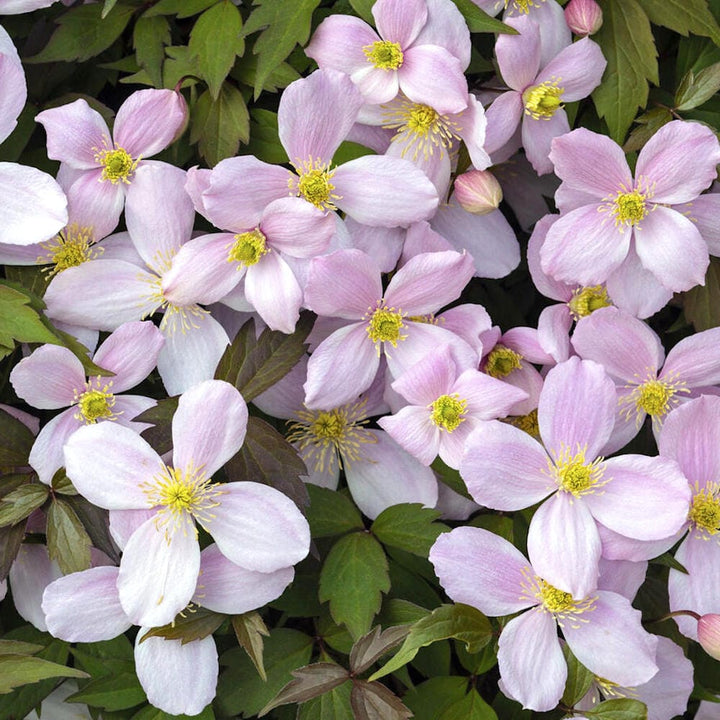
[592,0,659,144]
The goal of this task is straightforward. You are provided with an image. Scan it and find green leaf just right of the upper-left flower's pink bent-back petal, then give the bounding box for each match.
[190,82,250,165]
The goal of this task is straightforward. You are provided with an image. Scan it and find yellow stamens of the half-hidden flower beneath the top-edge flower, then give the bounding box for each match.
[383,99,460,160]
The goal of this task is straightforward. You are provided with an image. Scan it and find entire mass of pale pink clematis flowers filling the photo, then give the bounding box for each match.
[0,0,720,720]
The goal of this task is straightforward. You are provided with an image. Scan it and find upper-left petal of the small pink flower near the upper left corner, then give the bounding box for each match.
[35,98,112,170]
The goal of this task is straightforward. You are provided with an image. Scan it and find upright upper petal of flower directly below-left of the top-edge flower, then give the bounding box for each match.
[278,68,363,167]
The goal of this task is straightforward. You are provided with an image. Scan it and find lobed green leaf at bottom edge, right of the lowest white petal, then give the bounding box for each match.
[215,628,313,718]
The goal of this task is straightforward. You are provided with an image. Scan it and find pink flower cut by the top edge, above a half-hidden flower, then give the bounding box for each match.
[305,0,470,113]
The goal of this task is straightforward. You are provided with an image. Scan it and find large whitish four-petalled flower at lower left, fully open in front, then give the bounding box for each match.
[65,380,310,626]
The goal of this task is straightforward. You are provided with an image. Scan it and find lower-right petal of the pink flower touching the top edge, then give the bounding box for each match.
[398,45,468,114]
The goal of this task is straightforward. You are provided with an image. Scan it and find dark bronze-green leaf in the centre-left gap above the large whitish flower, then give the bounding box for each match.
[215,313,314,402]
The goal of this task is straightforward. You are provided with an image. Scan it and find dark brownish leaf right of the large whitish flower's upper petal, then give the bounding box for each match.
[225,417,309,510]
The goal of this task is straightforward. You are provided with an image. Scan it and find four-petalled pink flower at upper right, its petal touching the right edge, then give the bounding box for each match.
[540,121,720,292]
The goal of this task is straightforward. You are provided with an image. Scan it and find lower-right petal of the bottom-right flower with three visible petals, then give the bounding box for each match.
[562,590,658,687]
